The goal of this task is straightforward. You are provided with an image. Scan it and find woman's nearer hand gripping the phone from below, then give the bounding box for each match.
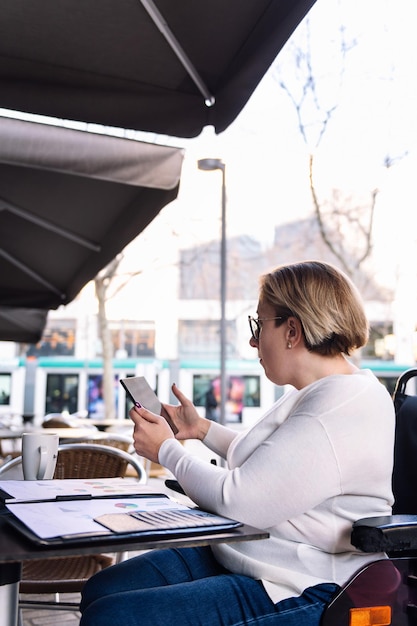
[129,406,174,463]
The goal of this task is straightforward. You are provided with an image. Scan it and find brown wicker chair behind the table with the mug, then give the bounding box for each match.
[0,443,146,610]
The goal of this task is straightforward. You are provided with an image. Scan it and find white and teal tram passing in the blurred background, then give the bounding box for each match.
[0,357,411,426]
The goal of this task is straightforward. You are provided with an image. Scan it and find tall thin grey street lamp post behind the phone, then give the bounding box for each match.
[198,159,227,424]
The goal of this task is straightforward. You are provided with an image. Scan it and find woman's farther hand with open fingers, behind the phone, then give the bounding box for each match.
[163,384,211,440]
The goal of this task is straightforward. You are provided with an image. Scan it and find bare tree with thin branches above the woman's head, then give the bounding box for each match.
[275,20,378,281]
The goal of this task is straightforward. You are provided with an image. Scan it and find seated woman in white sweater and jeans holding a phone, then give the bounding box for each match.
[81,261,394,626]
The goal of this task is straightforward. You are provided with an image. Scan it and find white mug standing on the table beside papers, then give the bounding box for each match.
[22,433,59,480]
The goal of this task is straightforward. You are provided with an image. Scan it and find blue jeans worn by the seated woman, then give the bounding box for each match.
[80,547,338,626]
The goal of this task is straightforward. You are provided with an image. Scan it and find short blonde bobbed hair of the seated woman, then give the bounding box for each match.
[260,261,369,355]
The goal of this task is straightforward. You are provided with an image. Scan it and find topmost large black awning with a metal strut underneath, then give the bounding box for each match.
[0,0,315,137]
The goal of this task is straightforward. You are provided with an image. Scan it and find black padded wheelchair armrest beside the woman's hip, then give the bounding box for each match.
[351,515,417,552]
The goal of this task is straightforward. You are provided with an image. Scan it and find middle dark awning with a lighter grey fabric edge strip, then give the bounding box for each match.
[0,118,184,309]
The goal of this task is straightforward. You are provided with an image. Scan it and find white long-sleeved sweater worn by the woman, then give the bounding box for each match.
[159,370,395,602]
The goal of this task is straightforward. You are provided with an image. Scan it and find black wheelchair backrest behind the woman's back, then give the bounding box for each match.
[392,368,417,515]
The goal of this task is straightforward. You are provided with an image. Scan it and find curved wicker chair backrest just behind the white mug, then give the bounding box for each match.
[0,443,146,483]
